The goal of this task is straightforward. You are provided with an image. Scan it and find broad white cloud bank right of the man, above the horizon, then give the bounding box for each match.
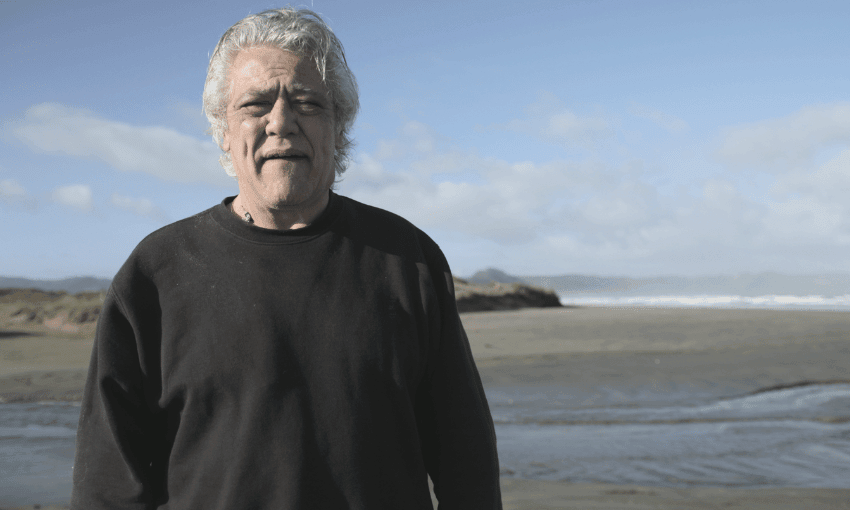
[340,116,850,274]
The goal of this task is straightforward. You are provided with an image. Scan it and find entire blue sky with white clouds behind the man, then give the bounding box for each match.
[0,0,850,279]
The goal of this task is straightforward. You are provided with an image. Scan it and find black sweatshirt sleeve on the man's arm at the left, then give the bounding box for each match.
[71,284,161,510]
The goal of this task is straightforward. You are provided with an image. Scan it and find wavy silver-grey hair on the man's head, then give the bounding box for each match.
[203,7,360,177]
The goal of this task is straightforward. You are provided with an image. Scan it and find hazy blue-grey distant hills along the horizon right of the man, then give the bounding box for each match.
[469,268,850,298]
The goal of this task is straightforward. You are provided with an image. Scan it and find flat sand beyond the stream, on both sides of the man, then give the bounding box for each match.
[0,307,850,403]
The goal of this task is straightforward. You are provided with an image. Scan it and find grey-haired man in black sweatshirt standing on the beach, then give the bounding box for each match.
[71,9,501,510]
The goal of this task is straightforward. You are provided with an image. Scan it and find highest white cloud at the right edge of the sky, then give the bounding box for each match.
[717,102,850,172]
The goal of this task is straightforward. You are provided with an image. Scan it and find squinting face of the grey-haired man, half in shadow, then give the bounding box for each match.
[222,47,337,214]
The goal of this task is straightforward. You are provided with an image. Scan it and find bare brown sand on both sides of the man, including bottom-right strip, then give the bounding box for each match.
[0,307,850,510]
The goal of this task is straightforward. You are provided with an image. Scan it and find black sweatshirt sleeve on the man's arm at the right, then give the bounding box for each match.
[419,253,502,510]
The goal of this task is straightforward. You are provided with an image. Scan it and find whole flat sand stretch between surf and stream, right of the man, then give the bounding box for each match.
[463,308,850,393]
